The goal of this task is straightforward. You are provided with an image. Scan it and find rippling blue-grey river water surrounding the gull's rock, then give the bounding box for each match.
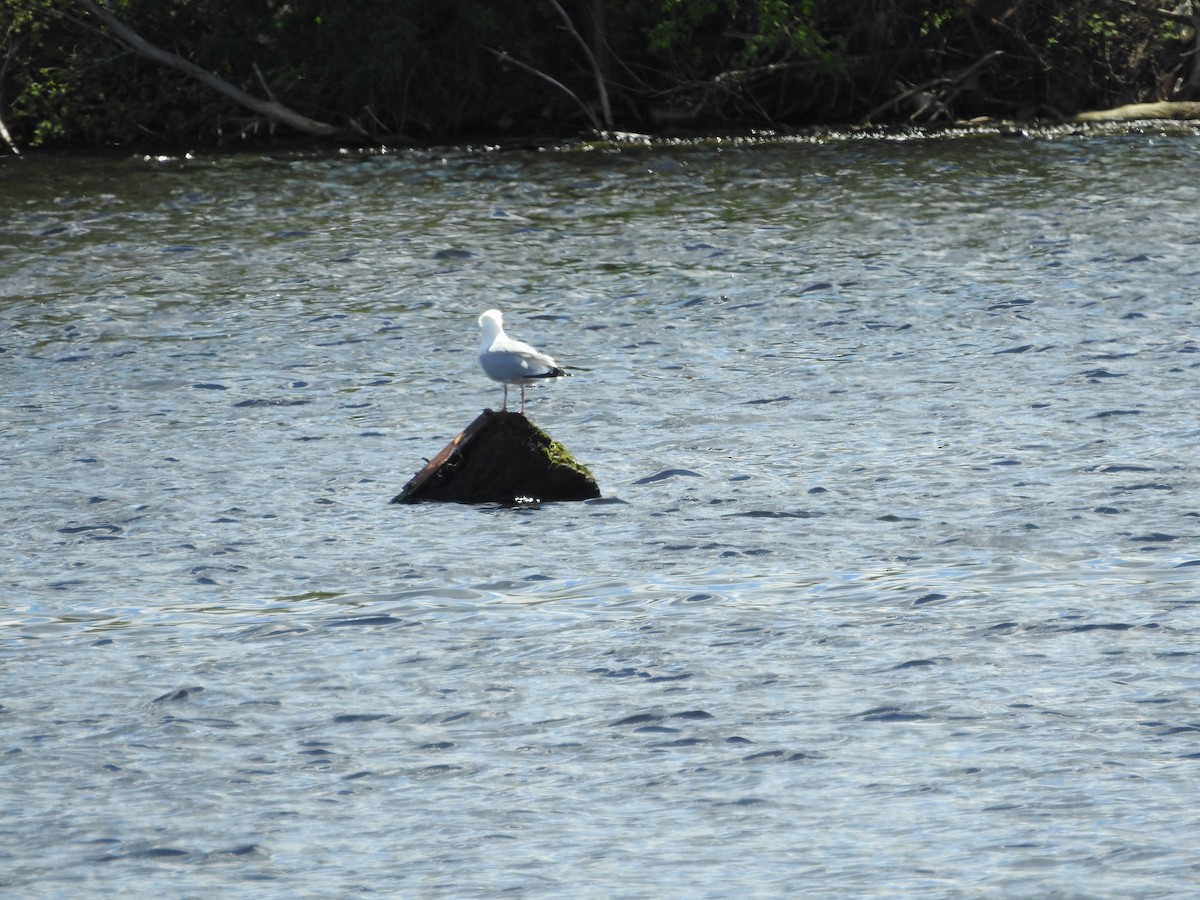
[0,134,1200,898]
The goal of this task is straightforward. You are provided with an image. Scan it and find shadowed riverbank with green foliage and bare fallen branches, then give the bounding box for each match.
[0,0,1200,150]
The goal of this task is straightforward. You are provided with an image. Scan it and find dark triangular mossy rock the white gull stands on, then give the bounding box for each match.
[392,409,600,504]
